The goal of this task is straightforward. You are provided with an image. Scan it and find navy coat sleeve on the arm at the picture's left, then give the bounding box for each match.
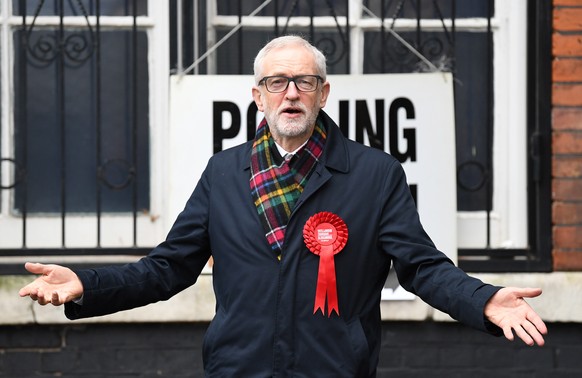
[65,159,212,319]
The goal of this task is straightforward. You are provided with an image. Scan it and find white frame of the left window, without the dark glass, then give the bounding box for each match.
[0,1,171,266]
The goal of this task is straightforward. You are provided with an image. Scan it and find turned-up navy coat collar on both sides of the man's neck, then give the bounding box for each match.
[240,110,350,173]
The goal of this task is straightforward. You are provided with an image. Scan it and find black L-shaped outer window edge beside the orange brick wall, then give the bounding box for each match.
[459,0,553,272]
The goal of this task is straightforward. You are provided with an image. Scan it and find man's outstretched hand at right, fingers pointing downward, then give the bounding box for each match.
[484,287,548,346]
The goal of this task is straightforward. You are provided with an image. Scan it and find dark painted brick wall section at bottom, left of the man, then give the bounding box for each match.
[0,323,207,378]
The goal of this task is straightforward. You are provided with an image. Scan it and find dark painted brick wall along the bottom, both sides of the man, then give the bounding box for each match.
[0,322,582,378]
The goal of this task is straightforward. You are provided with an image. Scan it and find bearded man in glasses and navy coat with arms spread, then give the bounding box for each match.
[20,36,547,377]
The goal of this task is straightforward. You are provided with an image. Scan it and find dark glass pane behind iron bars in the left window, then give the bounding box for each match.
[14,31,149,213]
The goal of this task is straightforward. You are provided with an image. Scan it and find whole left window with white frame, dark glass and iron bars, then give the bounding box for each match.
[0,0,168,256]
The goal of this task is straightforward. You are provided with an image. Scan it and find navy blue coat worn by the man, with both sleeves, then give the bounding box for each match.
[66,112,498,378]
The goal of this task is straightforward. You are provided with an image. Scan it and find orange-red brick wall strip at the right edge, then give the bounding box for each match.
[552,0,582,271]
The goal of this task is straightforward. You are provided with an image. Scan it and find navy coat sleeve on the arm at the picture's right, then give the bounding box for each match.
[379,161,500,334]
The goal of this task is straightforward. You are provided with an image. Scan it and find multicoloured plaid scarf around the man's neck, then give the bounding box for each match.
[250,119,326,257]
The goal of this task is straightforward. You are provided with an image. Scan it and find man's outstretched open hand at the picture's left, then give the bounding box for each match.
[18,263,83,306]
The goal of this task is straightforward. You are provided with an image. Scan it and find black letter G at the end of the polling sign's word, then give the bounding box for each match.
[388,97,416,163]
